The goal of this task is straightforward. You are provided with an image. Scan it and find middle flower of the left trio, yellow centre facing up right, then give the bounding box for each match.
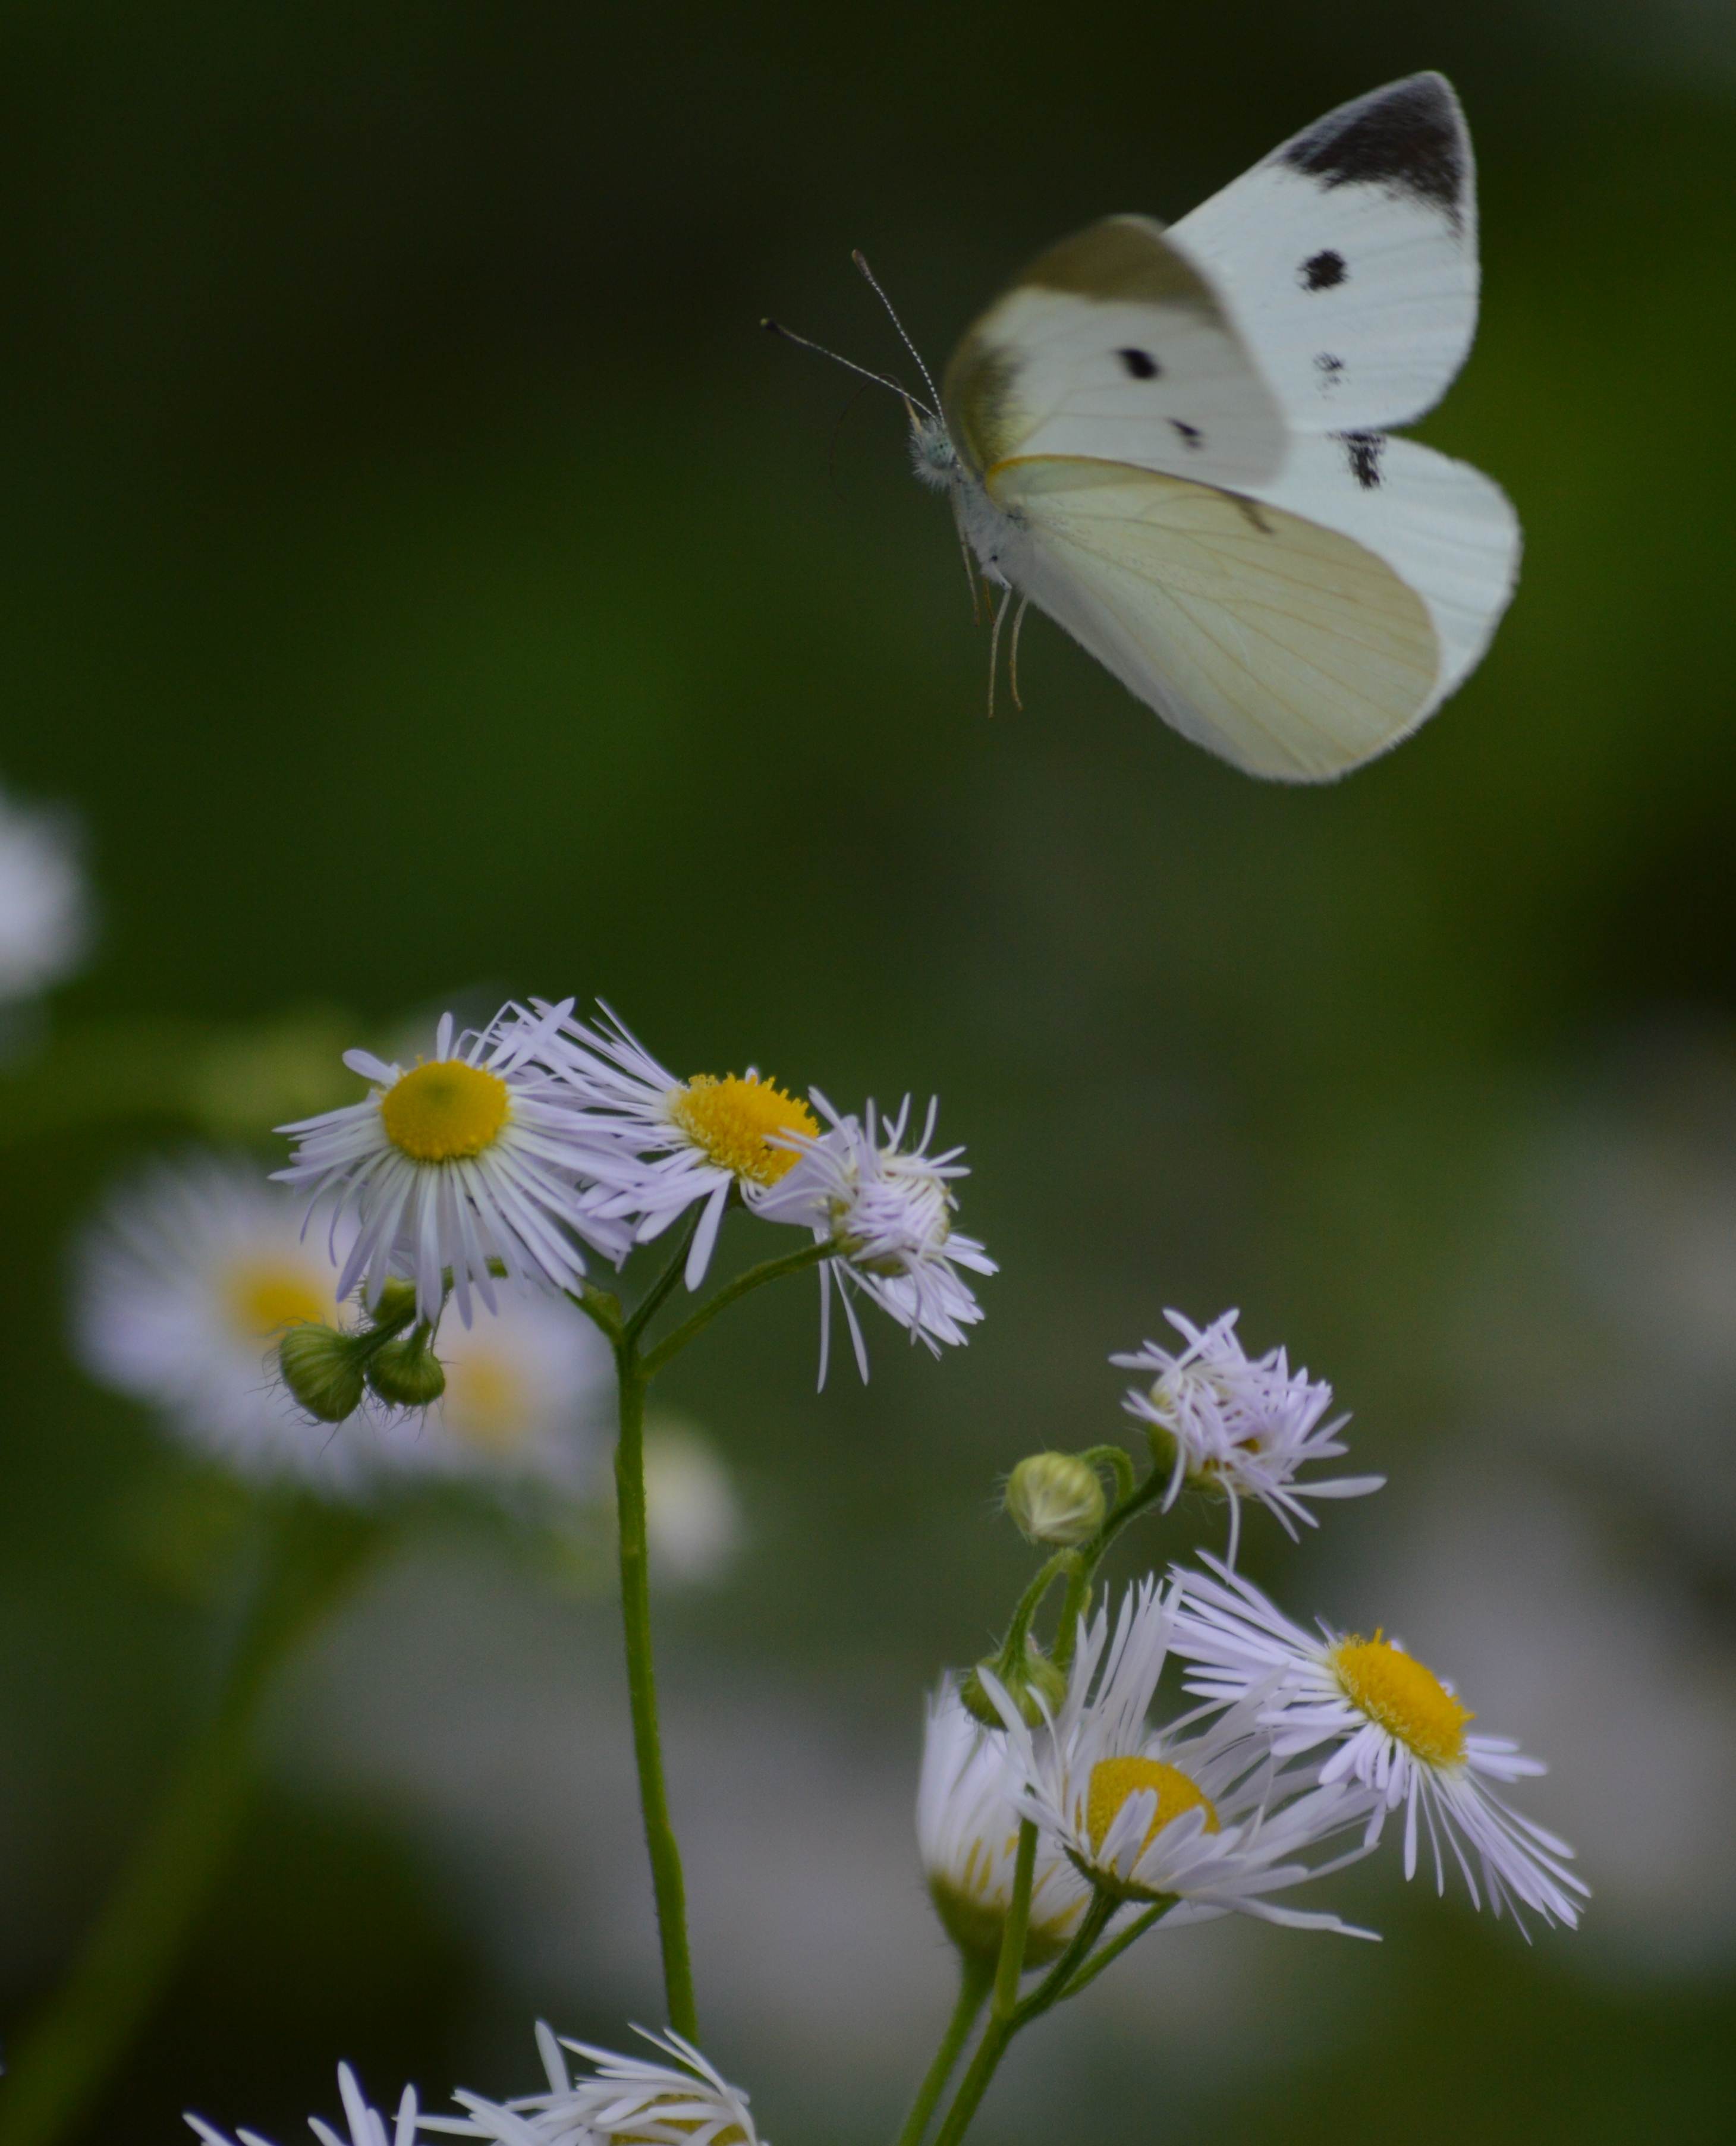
[532,1000,820,1290]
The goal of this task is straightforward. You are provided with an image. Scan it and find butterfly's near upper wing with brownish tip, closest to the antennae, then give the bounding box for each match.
[942,217,1285,485]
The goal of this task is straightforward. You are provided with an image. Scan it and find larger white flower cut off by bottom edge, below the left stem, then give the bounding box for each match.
[433,2022,762,2146]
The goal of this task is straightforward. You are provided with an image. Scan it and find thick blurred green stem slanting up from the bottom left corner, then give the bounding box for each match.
[0,1500,382,2146]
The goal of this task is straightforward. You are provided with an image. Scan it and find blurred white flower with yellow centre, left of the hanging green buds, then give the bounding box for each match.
[73,1154,369,1491]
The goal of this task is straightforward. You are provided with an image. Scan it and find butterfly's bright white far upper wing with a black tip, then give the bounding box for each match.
[1168,75,1476,432]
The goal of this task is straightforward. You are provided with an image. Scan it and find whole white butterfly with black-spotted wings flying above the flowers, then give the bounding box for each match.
[768,75,1519,781]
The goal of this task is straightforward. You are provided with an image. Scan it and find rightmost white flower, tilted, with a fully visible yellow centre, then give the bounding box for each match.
[1174,1558,1588,1929]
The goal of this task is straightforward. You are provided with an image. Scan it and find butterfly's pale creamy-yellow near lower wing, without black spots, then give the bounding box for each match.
[992,455,1442,781]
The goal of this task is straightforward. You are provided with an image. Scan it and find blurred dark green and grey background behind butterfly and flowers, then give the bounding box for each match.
[0,0,1736,2146]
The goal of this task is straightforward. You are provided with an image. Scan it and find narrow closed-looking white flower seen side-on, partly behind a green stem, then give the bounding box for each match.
[916,1676,1090,1968]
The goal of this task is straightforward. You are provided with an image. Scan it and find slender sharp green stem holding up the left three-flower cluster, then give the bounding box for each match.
[605,1335,700,2043]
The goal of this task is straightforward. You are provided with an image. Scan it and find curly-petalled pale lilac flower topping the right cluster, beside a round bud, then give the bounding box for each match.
[1109,1311,1386,1565]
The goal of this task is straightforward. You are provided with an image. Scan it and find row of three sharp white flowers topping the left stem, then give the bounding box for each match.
[277,1000,993,1382]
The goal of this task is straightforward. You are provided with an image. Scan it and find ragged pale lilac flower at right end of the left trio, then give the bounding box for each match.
[749,1088,996,1386]
